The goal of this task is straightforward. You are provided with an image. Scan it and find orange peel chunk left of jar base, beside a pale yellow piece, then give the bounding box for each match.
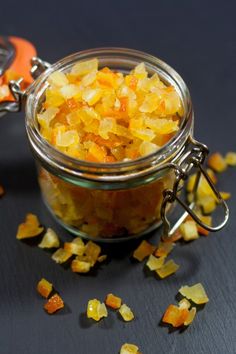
[16,214,44,240]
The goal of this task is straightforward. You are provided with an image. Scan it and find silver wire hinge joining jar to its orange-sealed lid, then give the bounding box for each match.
[0,57,50,116]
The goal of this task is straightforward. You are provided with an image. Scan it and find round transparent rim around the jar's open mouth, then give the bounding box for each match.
[25,47,193,182]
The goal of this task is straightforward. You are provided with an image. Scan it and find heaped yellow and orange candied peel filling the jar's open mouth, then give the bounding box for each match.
[37,59,182,163]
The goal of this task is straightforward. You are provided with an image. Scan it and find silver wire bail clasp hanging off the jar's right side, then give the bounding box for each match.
[161,138,229,239]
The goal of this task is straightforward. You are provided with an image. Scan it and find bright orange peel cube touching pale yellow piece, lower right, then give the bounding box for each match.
[162,305,189,327]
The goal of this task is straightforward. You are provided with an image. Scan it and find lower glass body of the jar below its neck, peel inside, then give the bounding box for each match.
[38,164,174,240]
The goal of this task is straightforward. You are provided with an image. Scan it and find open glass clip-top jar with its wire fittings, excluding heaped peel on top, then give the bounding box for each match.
[0,48,228,241]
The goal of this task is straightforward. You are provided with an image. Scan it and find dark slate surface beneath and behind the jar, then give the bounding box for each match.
[0,0,236,354]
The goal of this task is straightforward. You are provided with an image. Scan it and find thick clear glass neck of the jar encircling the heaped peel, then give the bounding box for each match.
[26,48,193,189]
